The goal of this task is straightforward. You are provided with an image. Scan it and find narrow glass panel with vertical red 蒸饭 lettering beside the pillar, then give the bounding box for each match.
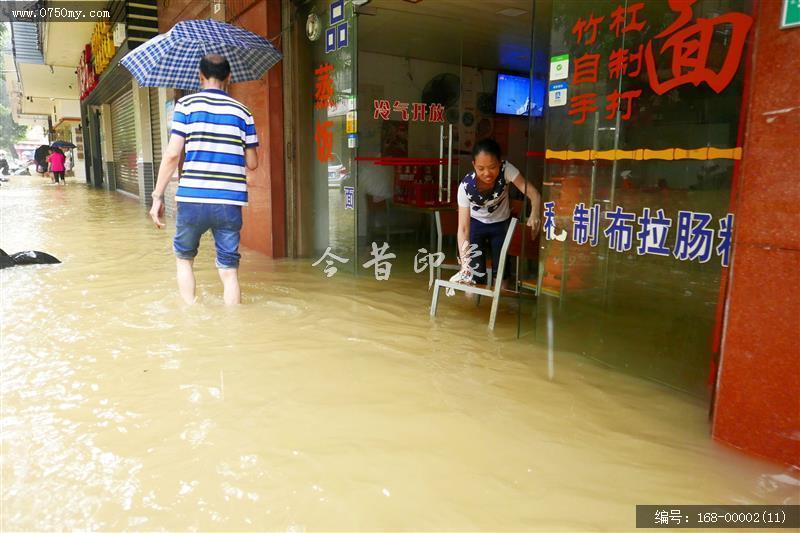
[288,0,356,272]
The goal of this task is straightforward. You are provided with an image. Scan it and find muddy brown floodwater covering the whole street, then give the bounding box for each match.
[0,177,800,531]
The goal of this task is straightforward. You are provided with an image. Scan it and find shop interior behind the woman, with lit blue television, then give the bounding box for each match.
[356,0,545,262]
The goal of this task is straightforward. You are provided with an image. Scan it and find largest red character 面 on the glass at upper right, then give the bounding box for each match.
[645,0,753,94]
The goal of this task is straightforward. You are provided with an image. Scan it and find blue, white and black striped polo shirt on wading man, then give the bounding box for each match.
[172,89,258,205]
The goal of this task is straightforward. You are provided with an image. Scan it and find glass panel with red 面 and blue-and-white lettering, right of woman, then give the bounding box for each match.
[529,0,752,398]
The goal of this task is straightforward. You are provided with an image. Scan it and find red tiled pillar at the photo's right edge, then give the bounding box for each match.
[713,1,800,466]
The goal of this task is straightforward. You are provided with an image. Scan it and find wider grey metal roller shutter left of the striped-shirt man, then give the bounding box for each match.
[111,88,139,196]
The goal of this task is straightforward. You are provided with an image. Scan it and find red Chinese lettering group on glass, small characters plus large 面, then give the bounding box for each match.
[550,0,753,124]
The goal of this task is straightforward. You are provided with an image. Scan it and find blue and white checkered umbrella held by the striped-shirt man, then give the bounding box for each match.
[120,20,283,90]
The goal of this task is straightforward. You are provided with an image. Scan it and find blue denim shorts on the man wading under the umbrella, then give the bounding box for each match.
[177,202,242,268]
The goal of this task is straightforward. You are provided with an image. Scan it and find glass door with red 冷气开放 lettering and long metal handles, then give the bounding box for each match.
[355,0,466,275]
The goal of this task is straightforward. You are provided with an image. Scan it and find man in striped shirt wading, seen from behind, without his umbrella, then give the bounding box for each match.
[150,54,258,305]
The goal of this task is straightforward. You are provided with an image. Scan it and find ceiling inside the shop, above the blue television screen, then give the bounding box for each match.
[358,0,532,72]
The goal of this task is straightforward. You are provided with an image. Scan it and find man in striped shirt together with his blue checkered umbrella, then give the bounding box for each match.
[120,20,281,305]
